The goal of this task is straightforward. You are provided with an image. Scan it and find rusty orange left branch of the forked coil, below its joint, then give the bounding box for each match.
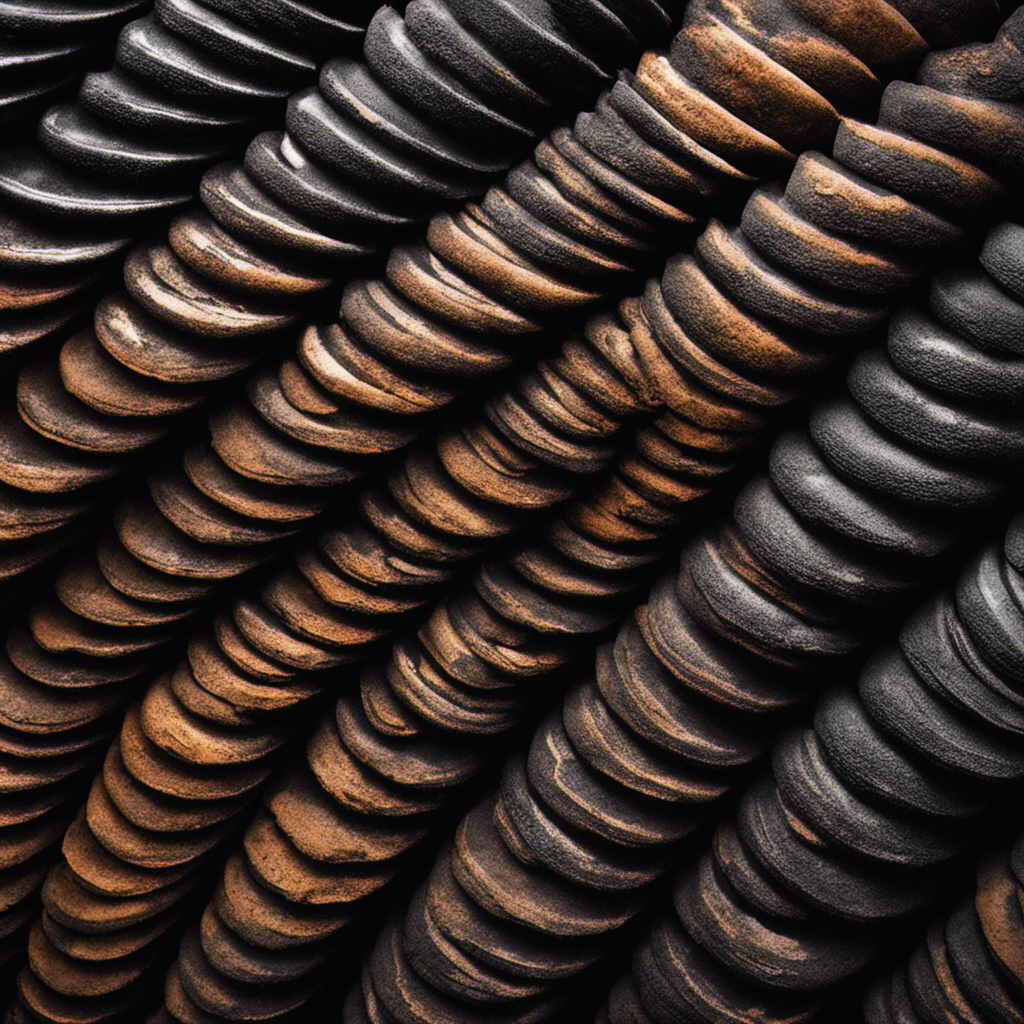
[12,301,655,1020]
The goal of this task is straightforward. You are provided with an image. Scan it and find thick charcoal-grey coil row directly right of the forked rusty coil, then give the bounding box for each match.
[327,52,1024,1022]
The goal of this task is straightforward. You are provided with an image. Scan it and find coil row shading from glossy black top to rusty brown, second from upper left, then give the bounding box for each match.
[0,0,688,578]
